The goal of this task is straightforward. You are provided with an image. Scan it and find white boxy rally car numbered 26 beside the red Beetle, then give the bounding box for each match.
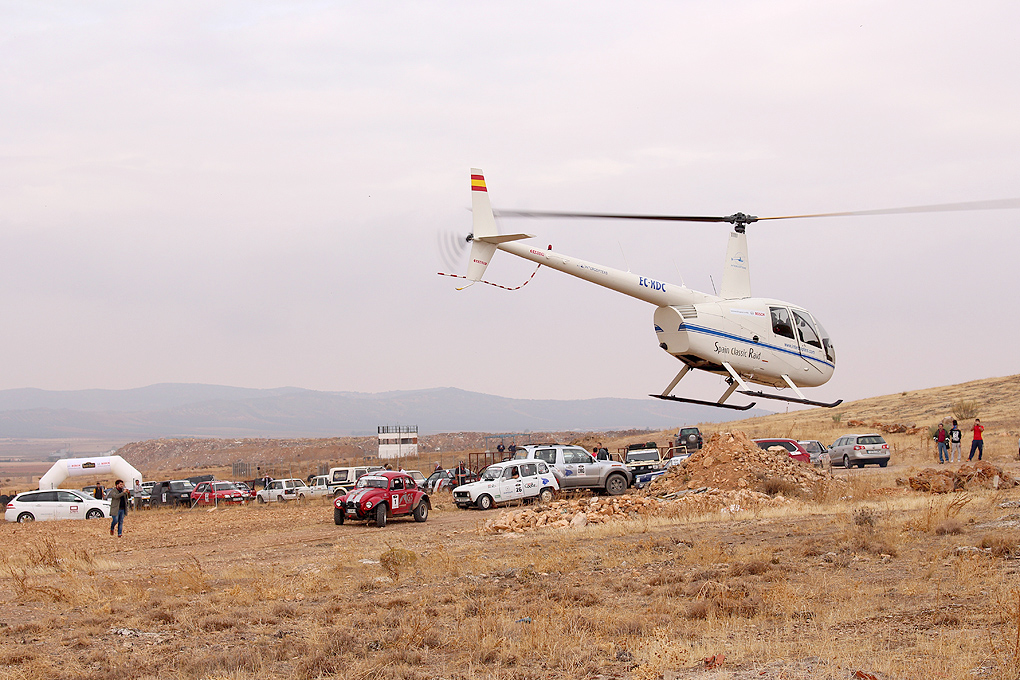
[453,461,560,510]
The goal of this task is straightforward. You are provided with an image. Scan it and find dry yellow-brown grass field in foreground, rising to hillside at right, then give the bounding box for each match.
[0,378,1020,680]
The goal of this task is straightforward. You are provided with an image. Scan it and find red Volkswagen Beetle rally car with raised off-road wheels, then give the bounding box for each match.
[333,470,431,527]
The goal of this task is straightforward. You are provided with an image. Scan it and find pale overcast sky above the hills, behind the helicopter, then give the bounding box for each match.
[0,0,1020,409]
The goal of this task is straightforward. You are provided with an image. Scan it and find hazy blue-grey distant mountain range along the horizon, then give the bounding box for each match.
[0,383,769,438]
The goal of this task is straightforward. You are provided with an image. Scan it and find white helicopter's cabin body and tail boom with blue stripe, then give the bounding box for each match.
[494,234,835,387]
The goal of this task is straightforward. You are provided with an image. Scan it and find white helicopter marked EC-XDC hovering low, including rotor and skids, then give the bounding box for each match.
[440,168,1020,411]
